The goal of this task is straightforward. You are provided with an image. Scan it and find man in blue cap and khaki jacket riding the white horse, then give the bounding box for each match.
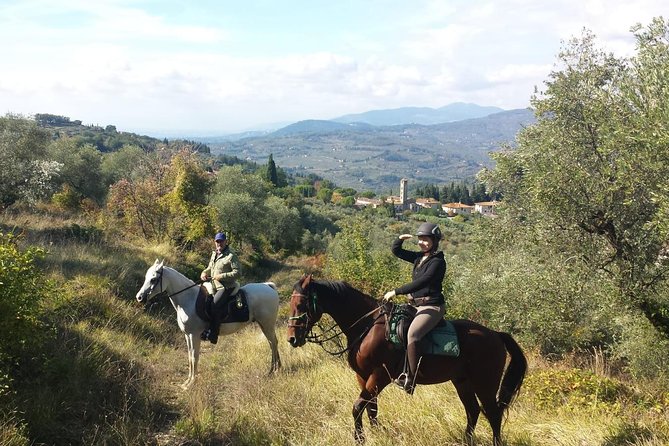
[200,232,242,344]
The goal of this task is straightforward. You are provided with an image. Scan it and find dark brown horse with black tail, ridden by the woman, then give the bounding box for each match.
[288,275,527,446]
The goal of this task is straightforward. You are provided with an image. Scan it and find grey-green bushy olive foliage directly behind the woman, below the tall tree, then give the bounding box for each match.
[448,219,621,355]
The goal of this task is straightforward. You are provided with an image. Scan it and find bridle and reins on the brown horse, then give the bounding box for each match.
[288,291,383,356]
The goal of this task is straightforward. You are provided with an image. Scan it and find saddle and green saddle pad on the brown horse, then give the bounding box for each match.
[383,303,460,357]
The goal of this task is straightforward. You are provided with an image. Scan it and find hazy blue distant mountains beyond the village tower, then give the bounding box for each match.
[198,104,534,194]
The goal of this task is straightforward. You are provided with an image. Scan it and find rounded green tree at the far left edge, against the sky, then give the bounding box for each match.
[0,114,62,208]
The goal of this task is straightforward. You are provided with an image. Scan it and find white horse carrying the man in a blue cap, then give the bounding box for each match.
[135,260,281,389]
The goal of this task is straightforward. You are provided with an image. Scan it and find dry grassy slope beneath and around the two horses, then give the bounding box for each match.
[0,210,669,446]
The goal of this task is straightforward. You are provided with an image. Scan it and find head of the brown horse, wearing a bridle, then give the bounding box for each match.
[288,274,323,347]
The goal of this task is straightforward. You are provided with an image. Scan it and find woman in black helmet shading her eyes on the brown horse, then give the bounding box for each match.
[383,222,446,395]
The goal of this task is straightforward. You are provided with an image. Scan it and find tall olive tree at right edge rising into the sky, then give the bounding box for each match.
[481,18,669,337]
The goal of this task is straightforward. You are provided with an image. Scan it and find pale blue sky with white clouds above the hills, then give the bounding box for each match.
[0,0,669,137]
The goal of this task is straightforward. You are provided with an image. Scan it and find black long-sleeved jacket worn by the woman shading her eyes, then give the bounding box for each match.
[392,238,446,305]
